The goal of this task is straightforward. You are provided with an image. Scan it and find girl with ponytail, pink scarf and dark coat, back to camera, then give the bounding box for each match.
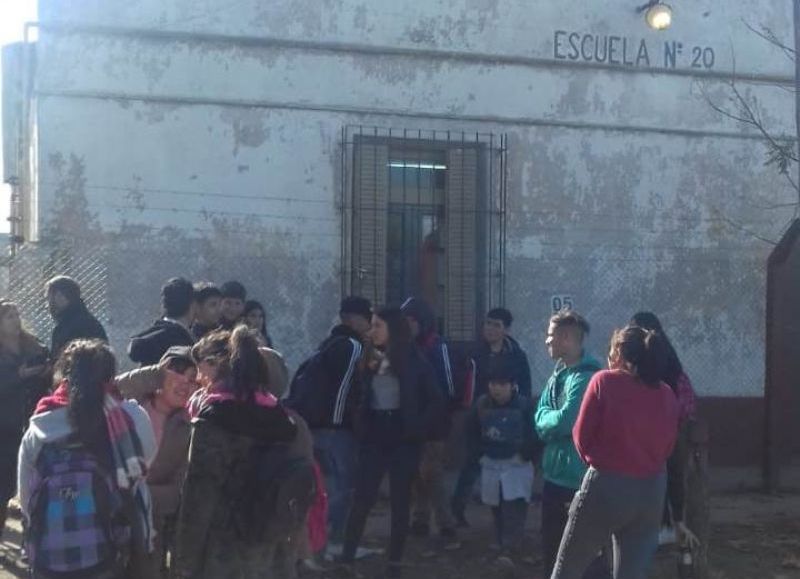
[172,326,297,579]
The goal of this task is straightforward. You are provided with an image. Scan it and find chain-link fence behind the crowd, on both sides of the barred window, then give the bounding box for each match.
[0,234,764,396]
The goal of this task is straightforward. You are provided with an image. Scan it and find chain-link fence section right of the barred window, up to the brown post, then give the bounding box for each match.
[507,250,764,397]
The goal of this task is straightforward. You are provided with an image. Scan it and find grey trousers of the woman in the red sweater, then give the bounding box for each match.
[551,468,667,579]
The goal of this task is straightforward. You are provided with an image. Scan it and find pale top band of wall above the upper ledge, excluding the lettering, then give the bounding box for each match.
[39,0,792,74]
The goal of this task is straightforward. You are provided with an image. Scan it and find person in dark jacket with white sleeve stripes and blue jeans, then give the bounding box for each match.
[286,297,372,555]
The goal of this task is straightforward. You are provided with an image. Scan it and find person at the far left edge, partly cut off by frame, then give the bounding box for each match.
[0,300,50,533]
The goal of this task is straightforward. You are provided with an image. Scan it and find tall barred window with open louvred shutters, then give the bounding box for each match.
[342,127,506,341]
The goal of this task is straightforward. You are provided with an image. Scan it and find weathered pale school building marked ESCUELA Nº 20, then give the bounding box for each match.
[4,0,800,476]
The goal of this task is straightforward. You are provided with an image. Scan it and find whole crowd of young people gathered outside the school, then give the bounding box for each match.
[0,276,697,579]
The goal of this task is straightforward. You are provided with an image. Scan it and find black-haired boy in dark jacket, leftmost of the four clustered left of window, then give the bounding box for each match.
[128,277,194,366]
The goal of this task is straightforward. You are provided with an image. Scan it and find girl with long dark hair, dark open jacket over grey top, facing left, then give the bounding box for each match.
[342,308,444,577]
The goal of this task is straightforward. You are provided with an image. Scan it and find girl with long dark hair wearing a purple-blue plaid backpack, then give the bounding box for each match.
[19,340,156,579]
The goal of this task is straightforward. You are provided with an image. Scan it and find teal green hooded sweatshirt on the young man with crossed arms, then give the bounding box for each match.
[534,353,601,490]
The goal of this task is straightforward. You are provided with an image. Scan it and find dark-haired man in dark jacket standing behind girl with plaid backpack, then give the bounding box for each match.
[45,275,108,359]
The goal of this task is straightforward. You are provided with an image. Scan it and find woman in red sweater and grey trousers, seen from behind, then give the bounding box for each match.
[552,326,678,579]
